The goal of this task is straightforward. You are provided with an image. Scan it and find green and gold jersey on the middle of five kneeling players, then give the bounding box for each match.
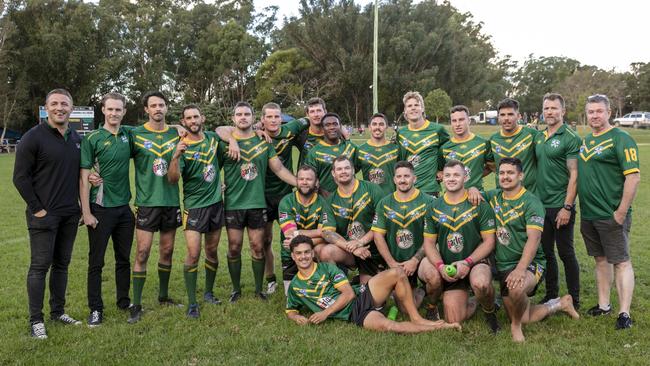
[372,189,434,262]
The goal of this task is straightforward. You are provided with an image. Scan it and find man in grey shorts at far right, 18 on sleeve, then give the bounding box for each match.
[578,95,641,329]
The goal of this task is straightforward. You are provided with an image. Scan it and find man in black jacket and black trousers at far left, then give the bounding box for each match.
[13,89,81,339]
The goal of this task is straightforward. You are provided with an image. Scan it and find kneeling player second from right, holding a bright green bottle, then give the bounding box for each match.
[420,160,499,333]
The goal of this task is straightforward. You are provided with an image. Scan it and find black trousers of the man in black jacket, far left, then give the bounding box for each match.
[26,212,79,323]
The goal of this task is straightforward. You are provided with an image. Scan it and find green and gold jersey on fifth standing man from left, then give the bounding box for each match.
[218,132,277,210]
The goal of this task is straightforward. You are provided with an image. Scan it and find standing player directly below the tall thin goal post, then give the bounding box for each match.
[356,113,399,195]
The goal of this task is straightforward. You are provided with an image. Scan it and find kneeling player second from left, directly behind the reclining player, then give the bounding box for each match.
[319,155,386,284]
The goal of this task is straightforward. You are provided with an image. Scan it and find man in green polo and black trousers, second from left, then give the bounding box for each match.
[79,93,135,327]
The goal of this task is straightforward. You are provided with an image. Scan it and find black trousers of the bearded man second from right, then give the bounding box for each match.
[542,208,580,301]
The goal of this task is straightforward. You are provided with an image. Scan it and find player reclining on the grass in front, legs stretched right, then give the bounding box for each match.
[286,235,460,333]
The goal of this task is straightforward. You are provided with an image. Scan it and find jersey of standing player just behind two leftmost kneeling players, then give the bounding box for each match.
[305,139,357,192]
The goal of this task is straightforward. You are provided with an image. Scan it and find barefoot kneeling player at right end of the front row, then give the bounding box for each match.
[486,158,580,342]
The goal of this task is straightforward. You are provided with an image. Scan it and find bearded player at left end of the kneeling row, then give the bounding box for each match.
[278,165,327,295]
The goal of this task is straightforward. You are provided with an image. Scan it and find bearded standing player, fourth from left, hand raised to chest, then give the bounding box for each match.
[167,104,224,318]
